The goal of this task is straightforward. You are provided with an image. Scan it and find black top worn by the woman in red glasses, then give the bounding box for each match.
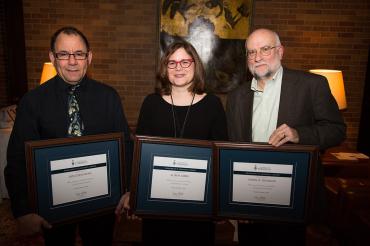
[136,94,228,140]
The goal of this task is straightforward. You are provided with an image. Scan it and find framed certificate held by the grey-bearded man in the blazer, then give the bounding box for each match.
[214,142,318,222]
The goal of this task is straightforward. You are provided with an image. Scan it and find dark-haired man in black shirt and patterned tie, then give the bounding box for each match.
[5,27,132,245]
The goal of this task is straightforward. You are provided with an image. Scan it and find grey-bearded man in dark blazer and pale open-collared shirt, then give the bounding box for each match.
[226,29,346,245]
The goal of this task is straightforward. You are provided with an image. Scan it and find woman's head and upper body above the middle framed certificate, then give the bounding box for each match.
[137,41,227,140]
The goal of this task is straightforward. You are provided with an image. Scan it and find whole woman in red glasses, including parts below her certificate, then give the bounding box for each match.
[116,41,228,245]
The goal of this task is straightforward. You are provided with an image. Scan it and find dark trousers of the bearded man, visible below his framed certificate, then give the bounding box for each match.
[238,222,306,246]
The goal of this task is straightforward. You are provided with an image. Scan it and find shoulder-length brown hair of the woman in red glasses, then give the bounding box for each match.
[155,40,205,95]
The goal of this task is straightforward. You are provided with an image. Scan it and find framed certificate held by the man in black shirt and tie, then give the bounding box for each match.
[26,133,124,224]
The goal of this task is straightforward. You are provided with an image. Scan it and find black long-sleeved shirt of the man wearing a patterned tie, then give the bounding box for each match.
[4,76,132,217]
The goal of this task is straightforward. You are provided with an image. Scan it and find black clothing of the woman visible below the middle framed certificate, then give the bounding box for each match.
[142,219,215,246]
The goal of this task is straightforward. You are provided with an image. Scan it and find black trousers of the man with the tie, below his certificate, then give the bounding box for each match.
[44,214,115,246]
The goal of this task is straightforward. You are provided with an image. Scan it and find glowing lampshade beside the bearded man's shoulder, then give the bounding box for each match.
[310,69,347,109]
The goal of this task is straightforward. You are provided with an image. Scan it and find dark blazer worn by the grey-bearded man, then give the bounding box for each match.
[226,68,346,149]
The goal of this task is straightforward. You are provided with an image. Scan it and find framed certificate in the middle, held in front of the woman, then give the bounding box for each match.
[130,136,213,219]
